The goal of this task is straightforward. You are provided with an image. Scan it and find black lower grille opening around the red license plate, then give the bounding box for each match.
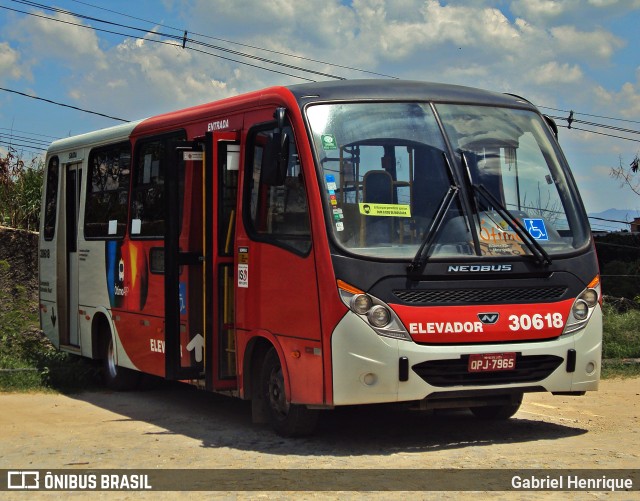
[412,353,563,387]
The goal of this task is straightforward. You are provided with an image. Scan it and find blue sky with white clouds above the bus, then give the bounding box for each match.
[0,0,640,229]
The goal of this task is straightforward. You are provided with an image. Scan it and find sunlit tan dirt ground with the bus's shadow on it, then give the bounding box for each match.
[0,378,640,499]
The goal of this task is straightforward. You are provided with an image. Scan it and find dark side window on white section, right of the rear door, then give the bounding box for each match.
[84,142,131,238]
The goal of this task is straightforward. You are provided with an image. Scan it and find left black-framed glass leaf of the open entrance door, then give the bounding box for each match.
[164,142,205,380]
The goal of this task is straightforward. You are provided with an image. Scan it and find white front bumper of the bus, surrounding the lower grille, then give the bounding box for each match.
[331,307,602,405]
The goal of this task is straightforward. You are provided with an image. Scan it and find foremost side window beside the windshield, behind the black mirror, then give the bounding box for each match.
[245,121,311,254]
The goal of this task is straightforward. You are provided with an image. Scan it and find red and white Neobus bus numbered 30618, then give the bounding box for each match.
[40,80,602,435]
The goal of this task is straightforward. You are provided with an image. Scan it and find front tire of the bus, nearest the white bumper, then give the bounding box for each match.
[260,348,319,437]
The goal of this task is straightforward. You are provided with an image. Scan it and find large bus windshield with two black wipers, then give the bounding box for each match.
[307,102,588,259]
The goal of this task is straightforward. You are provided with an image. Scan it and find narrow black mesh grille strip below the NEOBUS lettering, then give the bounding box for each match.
[393,286,567,304]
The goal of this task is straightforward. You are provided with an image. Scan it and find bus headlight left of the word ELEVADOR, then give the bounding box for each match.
[338,280,412,341]
